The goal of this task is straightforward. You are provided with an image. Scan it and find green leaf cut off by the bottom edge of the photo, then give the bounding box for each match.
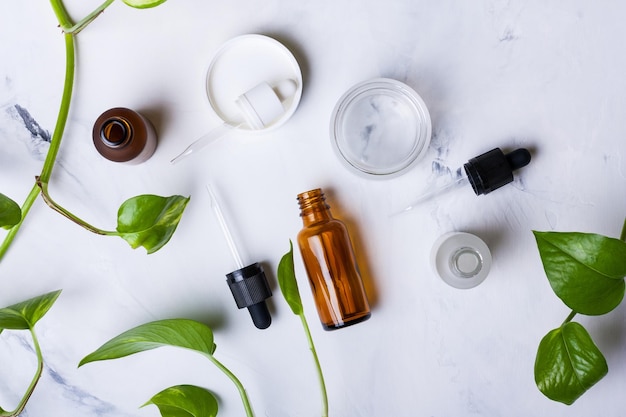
[142,385,218,417]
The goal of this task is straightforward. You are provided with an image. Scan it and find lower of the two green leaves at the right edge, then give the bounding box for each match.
[535,322,608,405]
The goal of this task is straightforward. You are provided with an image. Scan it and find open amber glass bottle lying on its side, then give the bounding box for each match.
[298,188,371,330]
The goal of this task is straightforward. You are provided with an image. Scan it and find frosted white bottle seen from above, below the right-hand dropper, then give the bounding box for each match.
[430,232,492,289]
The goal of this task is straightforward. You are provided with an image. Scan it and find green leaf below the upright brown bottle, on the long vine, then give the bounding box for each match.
[117,194,189,253]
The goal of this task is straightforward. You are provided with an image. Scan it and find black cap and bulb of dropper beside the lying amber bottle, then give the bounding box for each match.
[226,263,272,329]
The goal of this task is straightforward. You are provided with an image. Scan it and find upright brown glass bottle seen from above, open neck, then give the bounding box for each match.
[92,107,157,164]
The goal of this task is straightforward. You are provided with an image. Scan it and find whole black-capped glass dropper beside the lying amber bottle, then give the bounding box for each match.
[207,186,272,329]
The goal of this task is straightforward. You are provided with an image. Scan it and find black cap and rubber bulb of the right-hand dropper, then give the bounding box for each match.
[463,148,530,195]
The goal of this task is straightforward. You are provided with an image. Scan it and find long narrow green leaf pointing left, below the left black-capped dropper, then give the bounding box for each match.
[78,319,215,366]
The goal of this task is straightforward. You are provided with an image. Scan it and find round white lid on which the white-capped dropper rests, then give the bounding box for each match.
[206,34,302,131]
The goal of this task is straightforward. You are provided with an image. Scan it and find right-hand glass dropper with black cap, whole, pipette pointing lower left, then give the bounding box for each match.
[395,148,530,214]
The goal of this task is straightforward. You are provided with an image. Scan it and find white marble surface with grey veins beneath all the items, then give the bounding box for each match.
[0,0,626,417]
